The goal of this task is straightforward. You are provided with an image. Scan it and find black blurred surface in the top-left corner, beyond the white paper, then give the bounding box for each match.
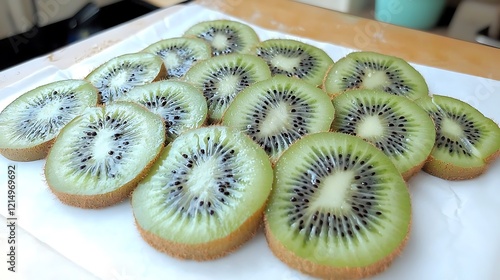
[0,0,164,71]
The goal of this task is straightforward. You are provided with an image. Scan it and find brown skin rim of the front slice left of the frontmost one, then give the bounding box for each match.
[134,203,267,261]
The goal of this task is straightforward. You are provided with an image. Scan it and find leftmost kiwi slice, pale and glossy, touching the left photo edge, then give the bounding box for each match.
[0,79,99,161]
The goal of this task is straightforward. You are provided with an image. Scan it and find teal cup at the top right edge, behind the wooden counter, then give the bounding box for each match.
[375,0,446,30]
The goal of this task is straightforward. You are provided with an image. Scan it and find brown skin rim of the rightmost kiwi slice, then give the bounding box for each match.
[423,150,500,181]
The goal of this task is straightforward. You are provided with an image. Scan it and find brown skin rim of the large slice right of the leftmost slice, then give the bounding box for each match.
[44,147,163,209]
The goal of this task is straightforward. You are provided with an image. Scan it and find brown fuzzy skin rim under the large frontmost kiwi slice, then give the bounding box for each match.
[264,210,412,280]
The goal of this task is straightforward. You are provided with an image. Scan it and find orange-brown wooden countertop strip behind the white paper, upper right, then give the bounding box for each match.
[173,0,500,80]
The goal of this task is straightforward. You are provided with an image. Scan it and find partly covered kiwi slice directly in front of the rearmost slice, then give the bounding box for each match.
[184,54,271,123]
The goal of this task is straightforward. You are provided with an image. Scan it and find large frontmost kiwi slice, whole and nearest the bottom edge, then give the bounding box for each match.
[265,132,411,279]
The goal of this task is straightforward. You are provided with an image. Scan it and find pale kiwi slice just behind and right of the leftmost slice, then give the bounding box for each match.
[85,52,166,104]
